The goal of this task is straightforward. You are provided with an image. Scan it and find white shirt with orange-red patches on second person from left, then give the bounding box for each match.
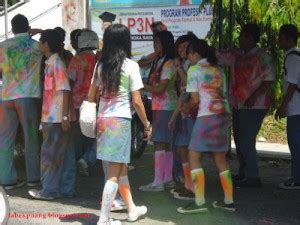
[42,54,75,123]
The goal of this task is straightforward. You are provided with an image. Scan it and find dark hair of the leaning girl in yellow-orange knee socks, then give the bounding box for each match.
[187,39,218,66]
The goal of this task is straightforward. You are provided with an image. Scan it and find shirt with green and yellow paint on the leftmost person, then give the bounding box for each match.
[0,33,42,101]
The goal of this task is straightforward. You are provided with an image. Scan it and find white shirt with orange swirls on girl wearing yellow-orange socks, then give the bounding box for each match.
[186,59,230,117]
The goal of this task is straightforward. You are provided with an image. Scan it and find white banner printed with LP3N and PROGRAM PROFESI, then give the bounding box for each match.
[91,5,212,59]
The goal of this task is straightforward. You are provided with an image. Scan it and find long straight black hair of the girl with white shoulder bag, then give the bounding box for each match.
[98,24,131,94]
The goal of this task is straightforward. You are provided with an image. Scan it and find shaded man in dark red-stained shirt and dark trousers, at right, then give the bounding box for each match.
[218,23,275,187]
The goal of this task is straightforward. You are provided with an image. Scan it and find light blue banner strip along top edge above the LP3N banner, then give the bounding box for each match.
[90,0,202,9]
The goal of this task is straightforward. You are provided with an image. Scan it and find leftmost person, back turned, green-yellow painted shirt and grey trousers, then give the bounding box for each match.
[0,14,42,189]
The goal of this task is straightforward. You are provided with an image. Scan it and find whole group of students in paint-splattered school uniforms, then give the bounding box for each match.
[0,14,300,225]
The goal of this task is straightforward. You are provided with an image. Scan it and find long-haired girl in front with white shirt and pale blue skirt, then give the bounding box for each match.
[88,24,151,225]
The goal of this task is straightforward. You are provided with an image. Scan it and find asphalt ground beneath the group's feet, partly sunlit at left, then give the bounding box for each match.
[4,149,300,225]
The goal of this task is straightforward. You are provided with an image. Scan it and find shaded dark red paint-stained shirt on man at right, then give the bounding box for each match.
[218,48,276,109]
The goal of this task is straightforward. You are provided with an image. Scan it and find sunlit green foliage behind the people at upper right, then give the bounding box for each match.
[200,0,300,107]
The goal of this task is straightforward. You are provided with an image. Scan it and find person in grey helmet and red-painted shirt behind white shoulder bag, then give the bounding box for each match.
[67,29,99,176]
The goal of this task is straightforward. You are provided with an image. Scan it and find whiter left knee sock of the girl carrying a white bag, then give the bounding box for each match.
[99,180,119,223]
